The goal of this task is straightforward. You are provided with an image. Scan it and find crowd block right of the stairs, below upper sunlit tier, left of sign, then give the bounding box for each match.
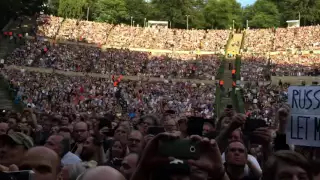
[241,51,320,128]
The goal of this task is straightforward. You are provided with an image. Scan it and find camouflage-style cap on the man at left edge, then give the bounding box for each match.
[0,132,34,149]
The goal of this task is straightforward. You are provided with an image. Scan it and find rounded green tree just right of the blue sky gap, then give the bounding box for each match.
[244,0,280,28]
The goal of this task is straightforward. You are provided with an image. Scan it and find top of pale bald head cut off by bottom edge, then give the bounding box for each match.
[80,166,125,180]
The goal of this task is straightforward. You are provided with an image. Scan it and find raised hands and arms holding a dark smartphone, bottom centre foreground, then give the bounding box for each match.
[131,133,228,180]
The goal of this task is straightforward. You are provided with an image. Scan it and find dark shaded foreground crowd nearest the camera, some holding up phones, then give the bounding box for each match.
[0,84,319,180]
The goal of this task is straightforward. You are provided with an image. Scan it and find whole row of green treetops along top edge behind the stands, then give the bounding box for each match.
[0,0,320,29]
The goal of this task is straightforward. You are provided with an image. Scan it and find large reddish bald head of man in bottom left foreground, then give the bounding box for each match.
[19,146,60,180]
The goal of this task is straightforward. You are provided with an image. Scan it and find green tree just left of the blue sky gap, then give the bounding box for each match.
[204,0,242,29]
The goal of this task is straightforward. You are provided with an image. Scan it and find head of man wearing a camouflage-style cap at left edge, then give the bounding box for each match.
[0,132,33,166]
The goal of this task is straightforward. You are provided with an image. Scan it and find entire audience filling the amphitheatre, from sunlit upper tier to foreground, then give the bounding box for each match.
[0,16,320,180]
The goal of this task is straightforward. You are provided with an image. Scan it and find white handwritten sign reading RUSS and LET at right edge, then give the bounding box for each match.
[286,86,320,147]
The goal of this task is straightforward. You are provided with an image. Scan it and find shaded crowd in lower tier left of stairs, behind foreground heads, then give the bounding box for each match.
[3,69,215,118]
